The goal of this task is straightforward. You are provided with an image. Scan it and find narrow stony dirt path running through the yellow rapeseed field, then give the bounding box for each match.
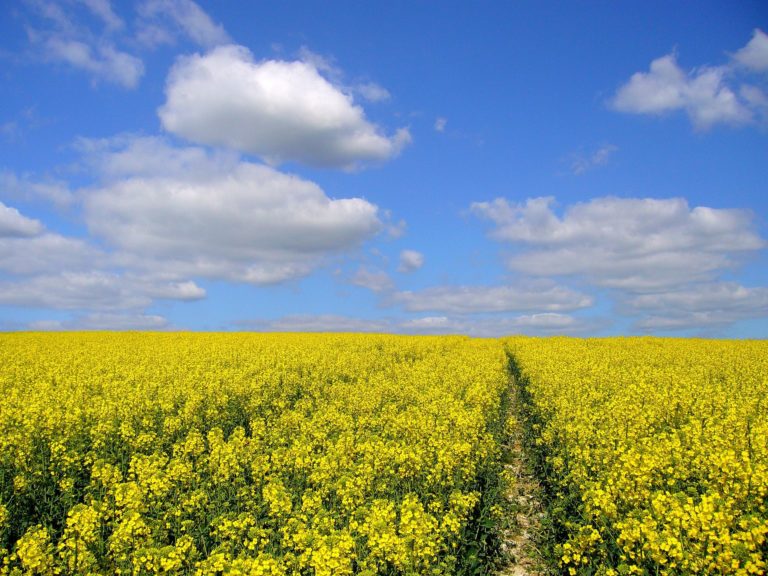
[497,379,551,576]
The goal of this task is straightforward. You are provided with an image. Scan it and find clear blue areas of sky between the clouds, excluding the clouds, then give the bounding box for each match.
[0,1,768,337]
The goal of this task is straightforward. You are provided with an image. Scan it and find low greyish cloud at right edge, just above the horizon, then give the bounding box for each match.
[625,282,768,330]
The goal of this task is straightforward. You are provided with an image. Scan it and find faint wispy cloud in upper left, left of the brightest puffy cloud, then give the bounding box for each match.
[43,35,144,88]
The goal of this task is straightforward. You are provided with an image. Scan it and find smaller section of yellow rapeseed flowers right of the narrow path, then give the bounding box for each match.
[505,338,768,575]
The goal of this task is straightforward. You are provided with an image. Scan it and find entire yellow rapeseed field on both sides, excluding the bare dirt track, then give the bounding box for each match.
[0,332,768,576]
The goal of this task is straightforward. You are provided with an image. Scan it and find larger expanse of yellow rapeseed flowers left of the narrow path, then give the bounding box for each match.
[0,333,508,576]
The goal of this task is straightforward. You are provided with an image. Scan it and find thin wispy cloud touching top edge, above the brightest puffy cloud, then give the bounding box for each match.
[138,0,230,48]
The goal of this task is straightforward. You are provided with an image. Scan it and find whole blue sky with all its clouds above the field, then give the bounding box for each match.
[0,0,768,338]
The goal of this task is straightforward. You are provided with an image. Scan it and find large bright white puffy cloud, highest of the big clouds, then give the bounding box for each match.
[159,46,410,168]
